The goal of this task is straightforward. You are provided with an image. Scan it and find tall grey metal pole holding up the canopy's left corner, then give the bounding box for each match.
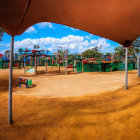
[8,36,14,125]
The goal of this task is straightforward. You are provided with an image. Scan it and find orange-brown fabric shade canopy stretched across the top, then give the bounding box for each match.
[0,0,140,46]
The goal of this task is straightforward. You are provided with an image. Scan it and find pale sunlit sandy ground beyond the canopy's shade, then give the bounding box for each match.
[0,67,137,97]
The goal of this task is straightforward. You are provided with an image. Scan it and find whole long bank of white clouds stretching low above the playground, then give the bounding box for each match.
[3,35,112,53]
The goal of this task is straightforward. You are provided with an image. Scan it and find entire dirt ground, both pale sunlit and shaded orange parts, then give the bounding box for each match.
[0,67,140,140]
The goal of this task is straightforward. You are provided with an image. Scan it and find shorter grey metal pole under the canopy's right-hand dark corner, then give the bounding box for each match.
[125,48,128,89]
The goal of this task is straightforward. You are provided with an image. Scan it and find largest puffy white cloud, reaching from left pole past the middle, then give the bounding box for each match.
[9,35,87,52]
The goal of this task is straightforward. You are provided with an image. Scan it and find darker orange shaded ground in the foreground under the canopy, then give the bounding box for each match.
[0,84,140,140]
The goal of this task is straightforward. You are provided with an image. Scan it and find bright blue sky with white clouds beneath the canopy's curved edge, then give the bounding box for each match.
[0,22,119,53]
